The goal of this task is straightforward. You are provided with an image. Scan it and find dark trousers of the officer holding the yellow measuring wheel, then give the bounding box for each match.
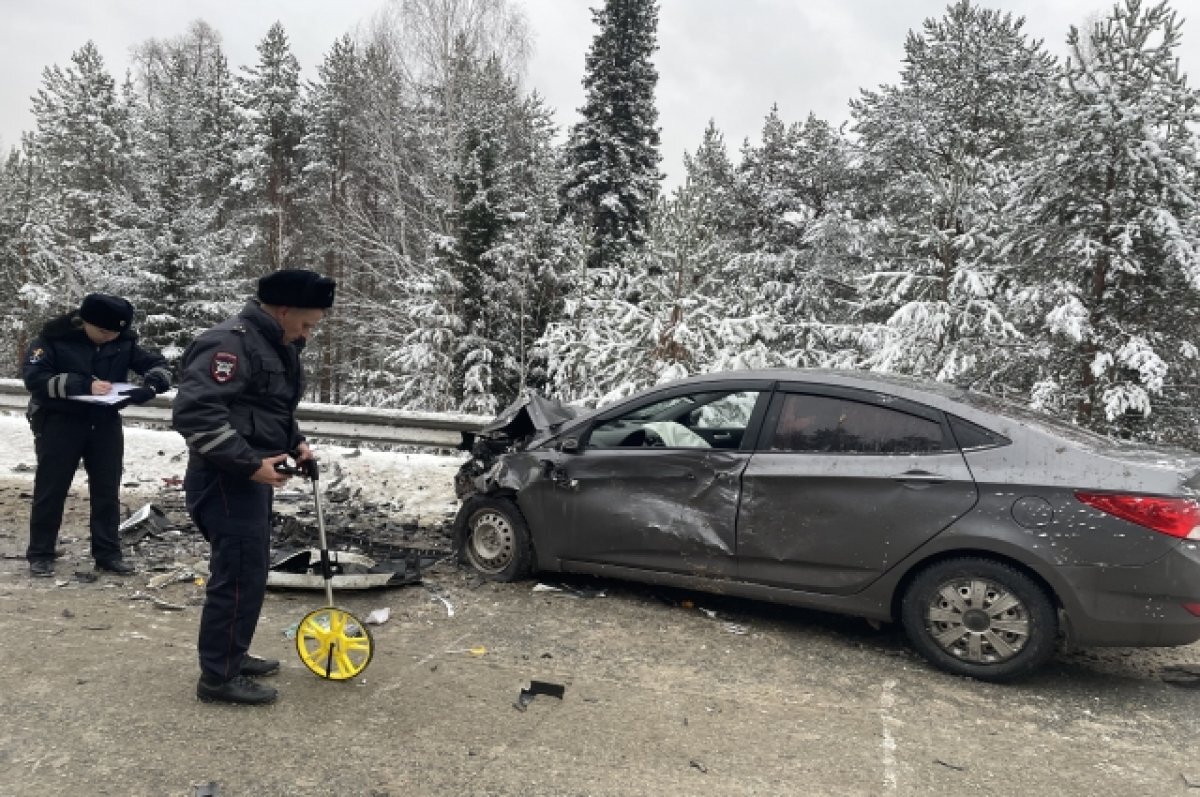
[184,467,274,681]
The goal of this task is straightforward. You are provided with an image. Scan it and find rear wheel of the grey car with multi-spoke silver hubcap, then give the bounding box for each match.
[900,557,1058,682]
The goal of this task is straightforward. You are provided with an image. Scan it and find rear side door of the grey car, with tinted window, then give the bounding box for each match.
[737,384,977,593]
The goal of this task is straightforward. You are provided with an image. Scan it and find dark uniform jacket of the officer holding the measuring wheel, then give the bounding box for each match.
[173,299,305,479]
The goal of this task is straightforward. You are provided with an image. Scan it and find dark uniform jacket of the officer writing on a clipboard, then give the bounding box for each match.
[22,313,170,418]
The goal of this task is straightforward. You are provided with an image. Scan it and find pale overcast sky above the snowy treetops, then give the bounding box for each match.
[0,0,1200,184]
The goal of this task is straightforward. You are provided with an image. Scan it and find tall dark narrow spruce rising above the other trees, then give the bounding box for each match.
[562,0,661,268]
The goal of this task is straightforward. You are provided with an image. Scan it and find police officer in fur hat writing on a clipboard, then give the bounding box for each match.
[22,293,170,576]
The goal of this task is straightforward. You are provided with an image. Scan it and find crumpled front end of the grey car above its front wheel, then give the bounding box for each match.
[454,390,582,501]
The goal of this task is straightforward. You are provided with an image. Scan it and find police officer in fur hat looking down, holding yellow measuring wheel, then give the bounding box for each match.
[174,269,336,705]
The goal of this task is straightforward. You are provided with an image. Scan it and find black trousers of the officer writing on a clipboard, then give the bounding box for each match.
[25,409,125,562]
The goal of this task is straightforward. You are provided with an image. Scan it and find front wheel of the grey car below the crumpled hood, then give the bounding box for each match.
[457,496,533,581]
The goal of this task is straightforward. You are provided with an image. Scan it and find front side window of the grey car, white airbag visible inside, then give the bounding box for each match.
[588,390,758,449]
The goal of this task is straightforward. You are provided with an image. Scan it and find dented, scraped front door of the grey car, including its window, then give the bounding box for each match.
[521,384,769,577]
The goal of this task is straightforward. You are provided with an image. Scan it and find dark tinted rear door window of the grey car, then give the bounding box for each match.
[768,394,954,454]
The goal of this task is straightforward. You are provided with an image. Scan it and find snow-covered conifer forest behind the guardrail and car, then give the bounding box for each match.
[0,0,1200,447]
